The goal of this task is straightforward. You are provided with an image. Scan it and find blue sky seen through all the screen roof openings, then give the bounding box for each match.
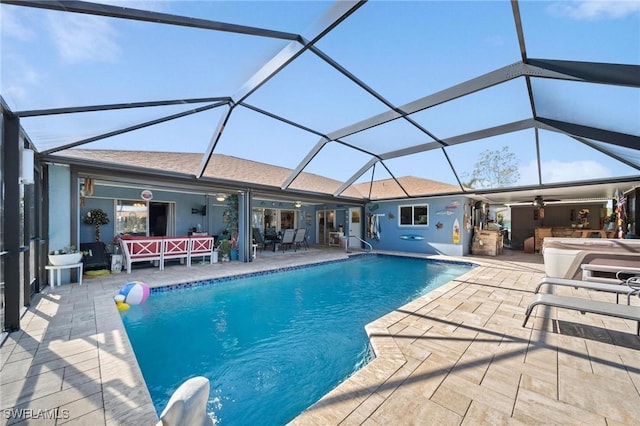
[0,0,640,190]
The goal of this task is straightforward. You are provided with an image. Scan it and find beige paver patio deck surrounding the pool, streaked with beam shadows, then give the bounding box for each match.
[0,248,640,425]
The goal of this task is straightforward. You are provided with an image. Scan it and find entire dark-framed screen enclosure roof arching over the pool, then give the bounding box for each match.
[0,0,640,205]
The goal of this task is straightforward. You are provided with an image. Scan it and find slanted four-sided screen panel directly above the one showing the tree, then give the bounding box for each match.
[411,78,531,139]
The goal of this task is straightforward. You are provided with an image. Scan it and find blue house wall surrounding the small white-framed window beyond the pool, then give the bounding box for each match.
[364,197,472,256]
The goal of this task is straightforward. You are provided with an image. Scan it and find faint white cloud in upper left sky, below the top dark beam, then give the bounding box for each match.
[49,13,120,63]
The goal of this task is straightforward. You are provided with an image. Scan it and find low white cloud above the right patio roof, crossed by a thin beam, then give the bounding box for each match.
[518,160,614,185]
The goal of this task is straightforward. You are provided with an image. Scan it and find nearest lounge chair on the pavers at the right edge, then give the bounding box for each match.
[522,293,640,336]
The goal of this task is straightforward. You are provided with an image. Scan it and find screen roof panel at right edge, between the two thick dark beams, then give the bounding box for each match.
[531,78,640,136]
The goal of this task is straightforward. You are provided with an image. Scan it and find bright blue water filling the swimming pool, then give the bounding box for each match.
[122,256,471,425]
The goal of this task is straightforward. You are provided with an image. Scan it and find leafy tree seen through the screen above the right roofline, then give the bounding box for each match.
[469,146,520,189]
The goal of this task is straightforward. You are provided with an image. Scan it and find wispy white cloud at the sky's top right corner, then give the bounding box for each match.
[549,0,640,21]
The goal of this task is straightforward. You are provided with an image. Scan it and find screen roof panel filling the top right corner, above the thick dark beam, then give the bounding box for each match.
[518,1,640,65]
